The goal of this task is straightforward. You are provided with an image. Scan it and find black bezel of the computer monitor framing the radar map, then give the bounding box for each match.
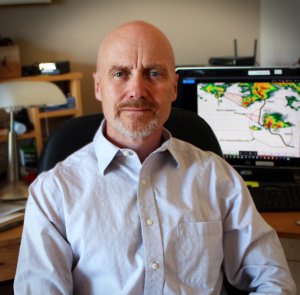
[173,67,300,178]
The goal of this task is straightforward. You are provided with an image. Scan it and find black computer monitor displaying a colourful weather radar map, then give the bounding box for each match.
[173,67,300,181]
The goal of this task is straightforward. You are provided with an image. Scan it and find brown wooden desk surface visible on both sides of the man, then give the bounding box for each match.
[0,212,300,282]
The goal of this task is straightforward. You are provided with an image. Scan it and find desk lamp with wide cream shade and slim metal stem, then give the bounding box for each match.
[0,81,66,200]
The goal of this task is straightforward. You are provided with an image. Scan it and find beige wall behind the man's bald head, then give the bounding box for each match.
[0,0,260,113]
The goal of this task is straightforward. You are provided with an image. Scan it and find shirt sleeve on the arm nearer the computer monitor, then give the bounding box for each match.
[223,177,296,295]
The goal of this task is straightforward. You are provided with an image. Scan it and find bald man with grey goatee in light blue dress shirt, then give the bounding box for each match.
[15,21,295,295]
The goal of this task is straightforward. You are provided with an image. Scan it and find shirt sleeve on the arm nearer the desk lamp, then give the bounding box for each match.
[14,174,73,295]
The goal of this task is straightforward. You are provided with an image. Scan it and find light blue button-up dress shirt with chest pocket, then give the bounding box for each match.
[14,121,295,295]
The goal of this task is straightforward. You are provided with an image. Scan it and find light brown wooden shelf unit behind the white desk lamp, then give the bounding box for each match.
[0,72,82,156]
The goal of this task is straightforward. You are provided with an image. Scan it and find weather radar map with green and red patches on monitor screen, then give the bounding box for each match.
[197,82,300,157]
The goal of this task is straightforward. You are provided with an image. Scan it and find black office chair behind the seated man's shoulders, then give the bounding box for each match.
[38,108,249,295]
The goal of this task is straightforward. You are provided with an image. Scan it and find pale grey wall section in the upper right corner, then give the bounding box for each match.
[260,0,300,66]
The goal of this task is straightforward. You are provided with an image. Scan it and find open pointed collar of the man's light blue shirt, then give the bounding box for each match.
[93,119,179,175]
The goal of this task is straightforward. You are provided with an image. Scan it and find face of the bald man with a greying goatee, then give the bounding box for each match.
[95,22,177,144]
